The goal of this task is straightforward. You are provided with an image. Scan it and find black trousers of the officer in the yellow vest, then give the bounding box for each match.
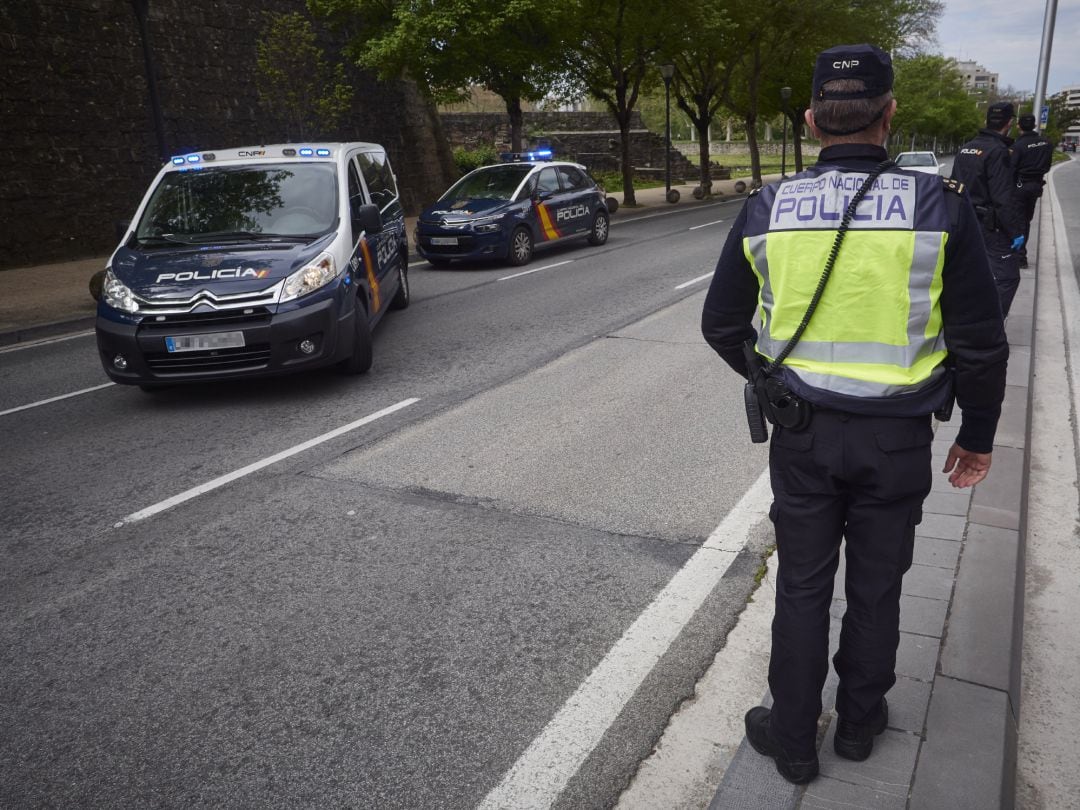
[769,409,933,759]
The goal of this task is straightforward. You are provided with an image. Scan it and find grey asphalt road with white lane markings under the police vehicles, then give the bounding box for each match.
[0,201,767,808]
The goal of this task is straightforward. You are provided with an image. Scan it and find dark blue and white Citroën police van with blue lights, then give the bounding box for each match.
[96,144,409,389]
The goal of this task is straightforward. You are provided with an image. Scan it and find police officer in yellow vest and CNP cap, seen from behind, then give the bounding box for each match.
[702,44,1009,783]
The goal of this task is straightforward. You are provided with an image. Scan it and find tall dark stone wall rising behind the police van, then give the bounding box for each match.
[0,0,456,269]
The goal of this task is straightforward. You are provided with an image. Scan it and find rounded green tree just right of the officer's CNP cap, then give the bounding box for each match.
[892,54,983,150]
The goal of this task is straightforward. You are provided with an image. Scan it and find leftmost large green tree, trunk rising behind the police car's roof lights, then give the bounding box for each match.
[308,0,578,151]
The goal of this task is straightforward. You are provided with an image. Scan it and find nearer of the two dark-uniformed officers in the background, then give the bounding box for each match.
[953,102,1025,318]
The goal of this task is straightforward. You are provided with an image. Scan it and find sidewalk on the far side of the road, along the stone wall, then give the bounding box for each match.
[0,175,760,346]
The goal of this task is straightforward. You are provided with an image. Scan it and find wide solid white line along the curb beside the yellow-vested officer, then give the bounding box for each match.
[477,469,772,810]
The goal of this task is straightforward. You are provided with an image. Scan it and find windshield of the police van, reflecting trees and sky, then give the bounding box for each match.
[135,163,338,243]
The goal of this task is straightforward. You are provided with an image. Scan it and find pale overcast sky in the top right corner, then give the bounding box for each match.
[937,0,1080,95]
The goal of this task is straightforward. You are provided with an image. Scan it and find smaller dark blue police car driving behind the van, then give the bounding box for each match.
[415,152,610,271]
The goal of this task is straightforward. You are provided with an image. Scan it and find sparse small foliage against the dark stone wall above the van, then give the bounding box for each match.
[255,12,352,140]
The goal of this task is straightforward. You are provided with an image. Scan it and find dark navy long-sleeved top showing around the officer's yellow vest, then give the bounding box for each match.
[701,144,1009,453]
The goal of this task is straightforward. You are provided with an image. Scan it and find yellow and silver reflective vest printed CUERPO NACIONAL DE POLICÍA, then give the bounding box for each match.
[743,171,947,396]
